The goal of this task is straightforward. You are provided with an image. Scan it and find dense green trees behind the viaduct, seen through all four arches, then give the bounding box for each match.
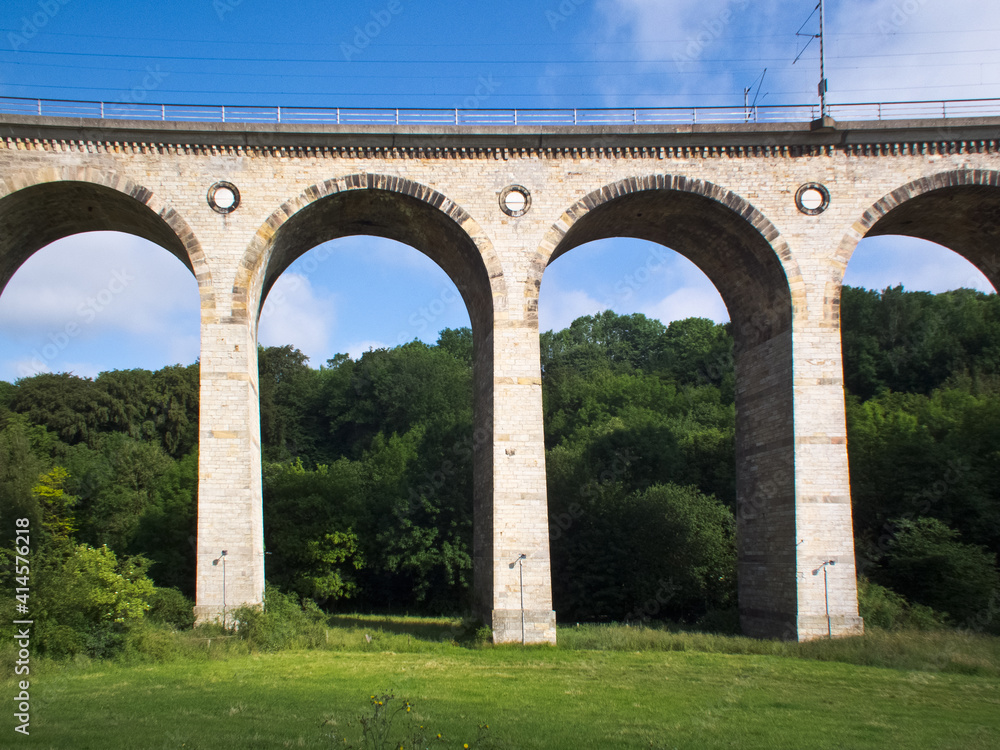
[0,288,1000,652]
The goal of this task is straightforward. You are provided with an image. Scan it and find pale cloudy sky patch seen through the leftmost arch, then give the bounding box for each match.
[0,232,201,379]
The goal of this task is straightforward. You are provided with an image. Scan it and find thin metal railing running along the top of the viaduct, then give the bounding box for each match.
[0,96,1000,127]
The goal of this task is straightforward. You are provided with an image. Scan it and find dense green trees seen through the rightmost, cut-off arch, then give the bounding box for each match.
[841,287,1000,633]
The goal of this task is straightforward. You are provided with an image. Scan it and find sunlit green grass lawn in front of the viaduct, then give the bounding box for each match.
[7,618,1000,750]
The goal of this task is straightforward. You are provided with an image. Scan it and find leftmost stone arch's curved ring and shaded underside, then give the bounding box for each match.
[0,167,215,311]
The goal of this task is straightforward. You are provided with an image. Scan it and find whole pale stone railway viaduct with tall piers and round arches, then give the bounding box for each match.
[0,111,1000,642]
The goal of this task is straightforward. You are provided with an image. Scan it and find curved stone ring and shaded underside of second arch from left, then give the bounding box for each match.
[233,173,506,340]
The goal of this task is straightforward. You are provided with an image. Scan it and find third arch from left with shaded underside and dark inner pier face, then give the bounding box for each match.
[529,175,804,638]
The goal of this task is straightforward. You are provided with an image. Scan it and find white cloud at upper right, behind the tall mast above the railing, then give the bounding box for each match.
[581,0,1000,106]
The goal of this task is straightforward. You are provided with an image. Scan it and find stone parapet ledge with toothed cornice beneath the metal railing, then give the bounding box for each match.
[0,114,1000,161]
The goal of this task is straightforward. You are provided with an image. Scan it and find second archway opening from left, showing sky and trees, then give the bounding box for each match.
[258,235,474,616]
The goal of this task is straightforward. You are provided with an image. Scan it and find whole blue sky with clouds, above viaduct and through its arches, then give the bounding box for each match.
[0,0,1000,380]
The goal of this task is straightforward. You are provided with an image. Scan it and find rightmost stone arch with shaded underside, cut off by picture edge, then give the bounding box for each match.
[831,169,1000,298]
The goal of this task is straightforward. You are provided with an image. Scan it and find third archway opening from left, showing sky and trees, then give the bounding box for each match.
[538,238,736,627]
